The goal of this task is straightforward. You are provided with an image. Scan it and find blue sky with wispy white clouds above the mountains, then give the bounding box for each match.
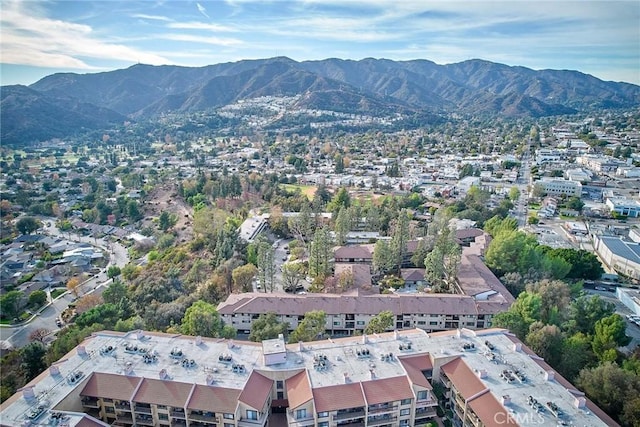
[0,0,640,85]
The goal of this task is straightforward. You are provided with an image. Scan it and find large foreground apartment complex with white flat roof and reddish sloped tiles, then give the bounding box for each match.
[0,329,615,427]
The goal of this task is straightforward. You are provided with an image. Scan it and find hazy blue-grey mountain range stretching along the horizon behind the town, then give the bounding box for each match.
[0,57,640,144]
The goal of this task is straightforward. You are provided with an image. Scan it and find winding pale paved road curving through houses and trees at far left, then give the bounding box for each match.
[0,220,129,348]
